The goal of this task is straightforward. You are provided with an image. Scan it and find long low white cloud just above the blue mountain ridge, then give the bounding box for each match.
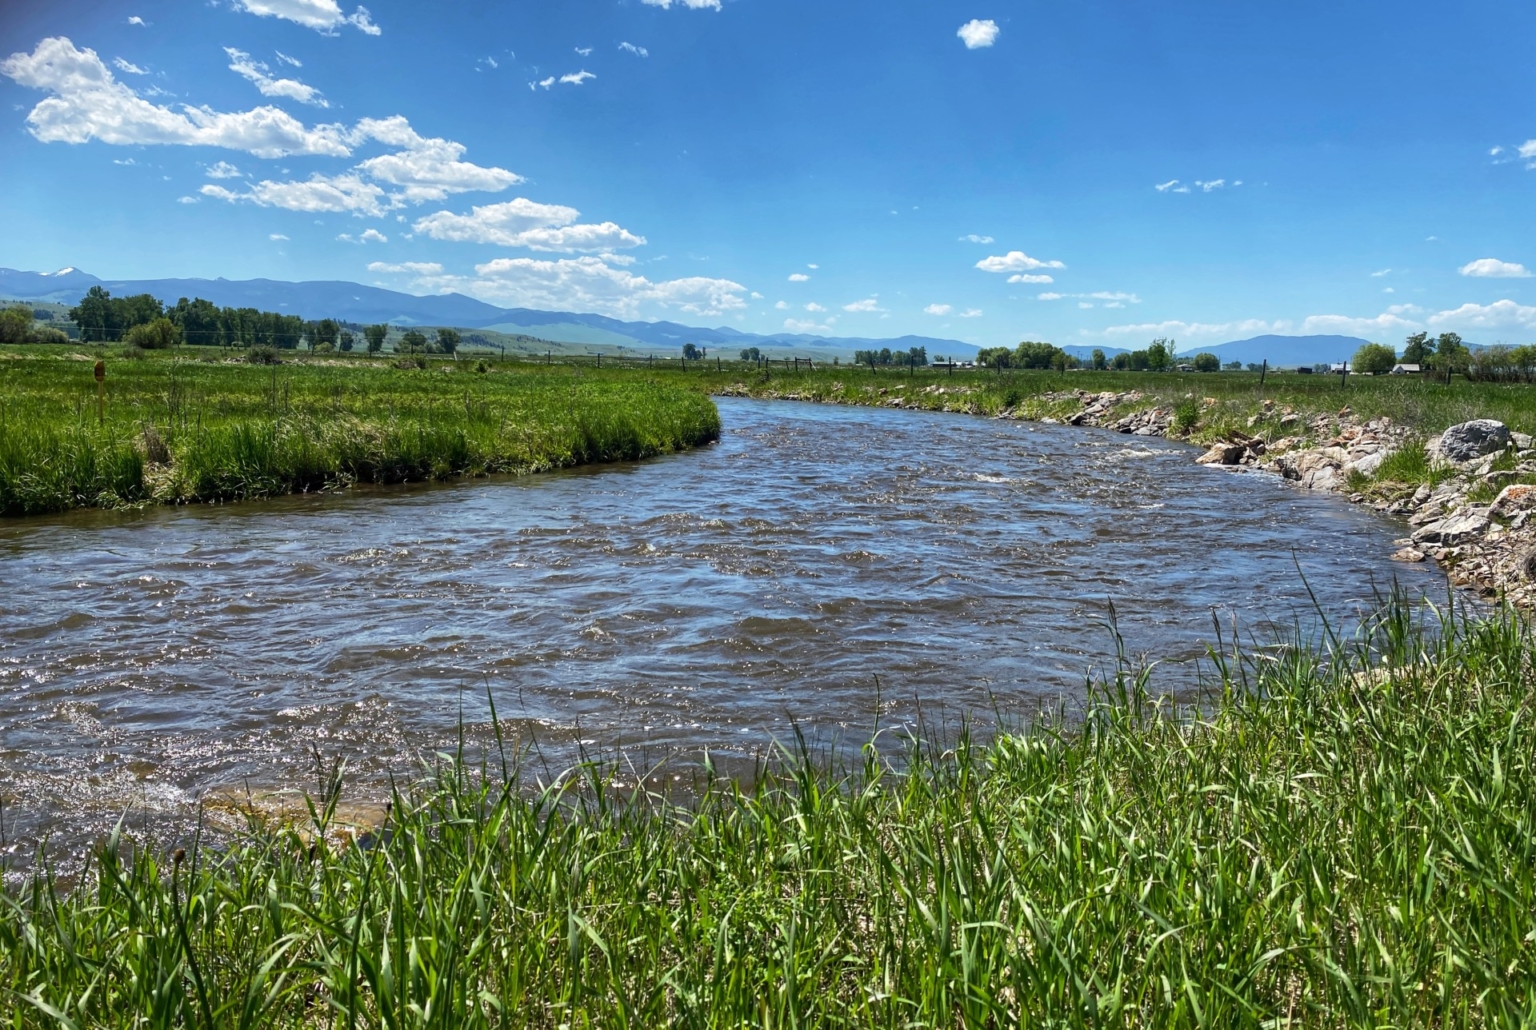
[402,256,746,318]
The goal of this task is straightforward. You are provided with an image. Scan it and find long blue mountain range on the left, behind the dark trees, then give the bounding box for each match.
[0,269,977,358]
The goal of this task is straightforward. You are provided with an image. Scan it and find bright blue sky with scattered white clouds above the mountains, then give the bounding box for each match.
[0,0,1536,350]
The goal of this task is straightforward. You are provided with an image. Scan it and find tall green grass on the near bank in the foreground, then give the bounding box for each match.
[0,603,1536,1027]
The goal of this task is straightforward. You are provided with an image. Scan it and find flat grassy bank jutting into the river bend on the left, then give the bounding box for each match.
[0,347,719,514]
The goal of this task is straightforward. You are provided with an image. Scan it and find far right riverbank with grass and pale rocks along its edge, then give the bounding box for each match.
[717,370,1536,609]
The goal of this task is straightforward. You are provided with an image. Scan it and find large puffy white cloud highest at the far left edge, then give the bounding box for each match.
[0,37,352,158]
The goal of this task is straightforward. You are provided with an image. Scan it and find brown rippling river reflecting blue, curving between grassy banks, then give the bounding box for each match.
[0,399,1445,855]
